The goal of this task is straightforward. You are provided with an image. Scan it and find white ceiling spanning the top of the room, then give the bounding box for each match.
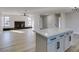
[0,7,72,15]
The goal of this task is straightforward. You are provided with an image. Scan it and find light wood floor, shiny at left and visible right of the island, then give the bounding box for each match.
[0,29,79,52]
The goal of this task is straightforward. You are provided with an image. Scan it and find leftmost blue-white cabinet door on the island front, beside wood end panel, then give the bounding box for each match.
[47,38,57,52]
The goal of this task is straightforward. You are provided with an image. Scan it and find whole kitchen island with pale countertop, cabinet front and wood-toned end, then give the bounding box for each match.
[35,28,73,52]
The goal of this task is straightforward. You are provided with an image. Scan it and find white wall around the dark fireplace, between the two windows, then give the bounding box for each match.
[2,15,28,28]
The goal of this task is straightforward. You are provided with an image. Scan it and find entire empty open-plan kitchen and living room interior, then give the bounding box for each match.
[0,7,79,52]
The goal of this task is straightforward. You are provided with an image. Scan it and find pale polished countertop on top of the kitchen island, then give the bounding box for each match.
[34,28,73,38]
